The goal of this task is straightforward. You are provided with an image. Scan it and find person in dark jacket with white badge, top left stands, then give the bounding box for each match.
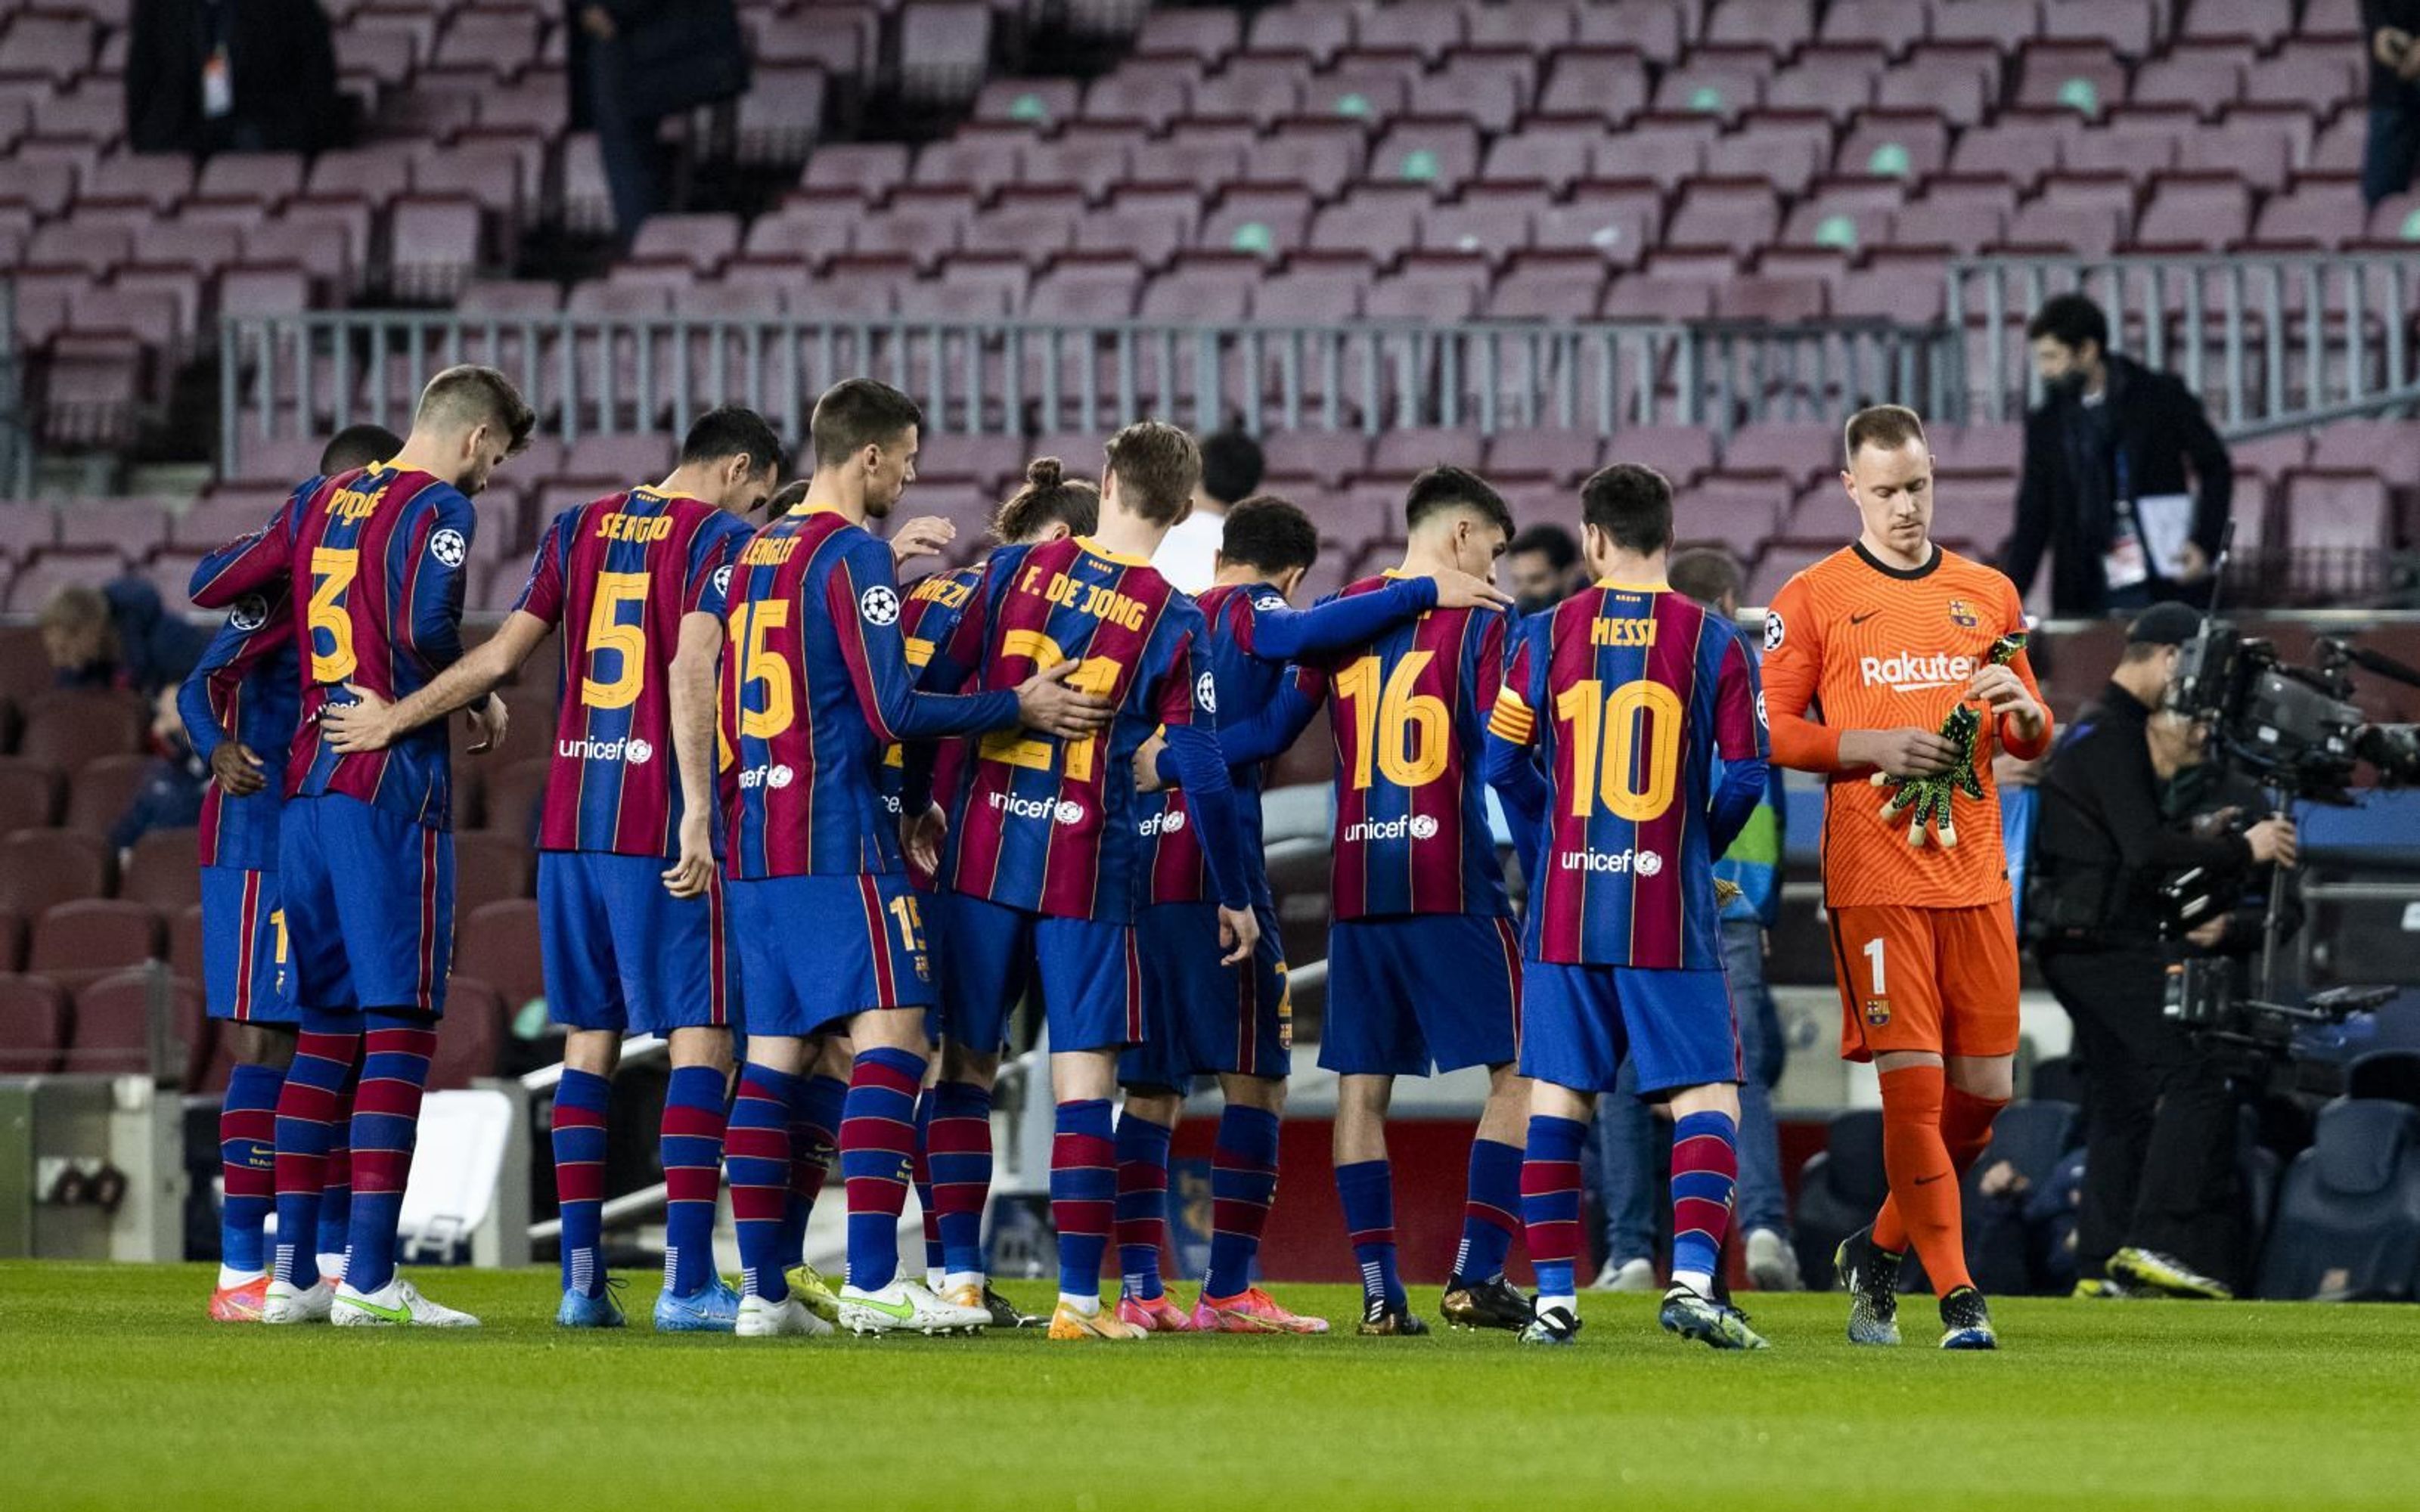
[126,0,343,153]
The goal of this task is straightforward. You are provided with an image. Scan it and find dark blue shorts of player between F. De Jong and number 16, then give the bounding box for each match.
[1118,903,1295,1089]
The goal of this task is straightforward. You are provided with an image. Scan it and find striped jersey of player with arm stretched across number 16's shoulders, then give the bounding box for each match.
[1135,578,1438,905]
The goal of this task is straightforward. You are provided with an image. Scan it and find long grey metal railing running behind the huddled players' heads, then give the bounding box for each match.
[218,312,1960,462]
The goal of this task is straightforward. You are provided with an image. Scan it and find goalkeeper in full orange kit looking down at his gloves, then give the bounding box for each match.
[1764,404,2049,1350]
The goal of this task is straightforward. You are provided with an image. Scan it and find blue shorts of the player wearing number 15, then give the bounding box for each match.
[724,873,932,1040]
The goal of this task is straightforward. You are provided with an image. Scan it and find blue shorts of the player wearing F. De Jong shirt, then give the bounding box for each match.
[932,893,1142,1055]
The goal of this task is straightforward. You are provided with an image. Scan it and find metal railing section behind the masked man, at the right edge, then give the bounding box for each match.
[1948,249,2420,433]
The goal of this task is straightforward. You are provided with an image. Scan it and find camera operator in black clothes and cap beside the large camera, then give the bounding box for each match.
[2025,605,2294,1297]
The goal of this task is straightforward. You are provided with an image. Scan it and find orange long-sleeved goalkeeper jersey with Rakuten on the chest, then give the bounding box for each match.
[1764,547,2049,907]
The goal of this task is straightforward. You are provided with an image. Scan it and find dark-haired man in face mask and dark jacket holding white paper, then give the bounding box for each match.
[2001,295,2234,617]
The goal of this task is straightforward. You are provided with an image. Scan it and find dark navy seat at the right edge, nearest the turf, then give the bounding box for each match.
[2260,1101,2420,1302]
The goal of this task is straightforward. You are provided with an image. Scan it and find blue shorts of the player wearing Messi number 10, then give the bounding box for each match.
[1520,960,1742,1098]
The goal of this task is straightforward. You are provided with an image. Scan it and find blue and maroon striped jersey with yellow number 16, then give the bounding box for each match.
[1292,573,1512,919]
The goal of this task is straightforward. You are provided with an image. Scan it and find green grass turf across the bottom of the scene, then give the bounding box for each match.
[0,1263,2420,1512]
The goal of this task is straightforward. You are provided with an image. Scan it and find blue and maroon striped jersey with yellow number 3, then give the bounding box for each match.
[194,464,476,830]
